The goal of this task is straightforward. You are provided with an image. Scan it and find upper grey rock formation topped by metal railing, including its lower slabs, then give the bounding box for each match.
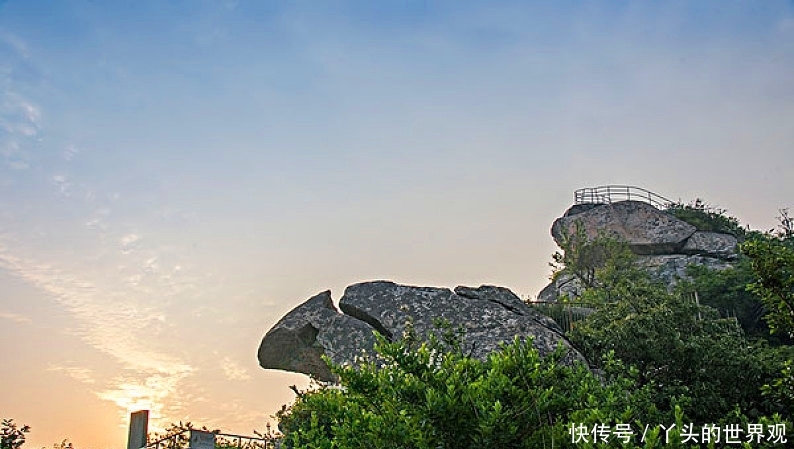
[538,201,738,301]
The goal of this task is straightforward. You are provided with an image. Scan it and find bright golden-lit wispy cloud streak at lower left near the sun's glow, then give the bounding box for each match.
[0,242,194,428]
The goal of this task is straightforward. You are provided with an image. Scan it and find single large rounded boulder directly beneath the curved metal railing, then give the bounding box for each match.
[551,201,696,254]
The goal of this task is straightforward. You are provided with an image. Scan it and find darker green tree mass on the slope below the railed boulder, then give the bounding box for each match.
[561,236,790,423]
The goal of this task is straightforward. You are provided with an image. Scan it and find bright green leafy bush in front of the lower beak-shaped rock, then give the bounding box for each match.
[278,322,662,449]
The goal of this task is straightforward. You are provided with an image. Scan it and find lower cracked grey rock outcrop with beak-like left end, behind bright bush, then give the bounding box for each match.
[259,281,584,380]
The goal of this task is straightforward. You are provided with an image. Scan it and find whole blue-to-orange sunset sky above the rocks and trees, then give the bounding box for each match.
[0,0,794,449]
